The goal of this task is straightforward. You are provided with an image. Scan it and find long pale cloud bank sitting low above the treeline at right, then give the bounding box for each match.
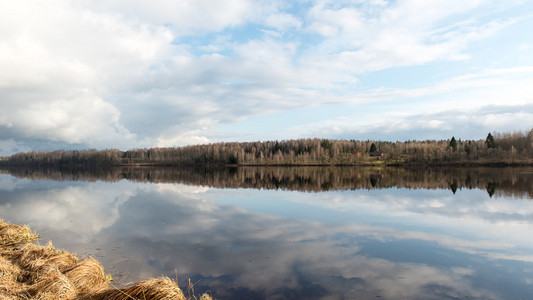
[251,66,533,140]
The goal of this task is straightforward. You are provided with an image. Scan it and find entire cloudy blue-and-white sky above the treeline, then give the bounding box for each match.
[0,0,533,155]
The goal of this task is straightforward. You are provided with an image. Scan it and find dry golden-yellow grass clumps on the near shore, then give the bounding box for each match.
[0,219,212,300]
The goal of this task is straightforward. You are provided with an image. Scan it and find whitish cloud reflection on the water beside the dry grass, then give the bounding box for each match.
[0,177,142,242]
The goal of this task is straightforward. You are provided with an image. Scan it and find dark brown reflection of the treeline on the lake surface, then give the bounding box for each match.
[1,166,533,198]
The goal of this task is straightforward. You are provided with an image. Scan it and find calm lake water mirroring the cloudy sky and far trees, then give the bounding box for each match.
[0,167,533,299]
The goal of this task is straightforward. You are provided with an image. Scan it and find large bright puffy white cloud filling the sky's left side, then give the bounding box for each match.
[0,1,172,147]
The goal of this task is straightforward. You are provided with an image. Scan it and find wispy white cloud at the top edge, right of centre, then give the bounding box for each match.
[308,0,513,73]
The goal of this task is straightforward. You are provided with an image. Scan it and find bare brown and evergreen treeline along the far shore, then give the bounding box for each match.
[4,129,533,167]
